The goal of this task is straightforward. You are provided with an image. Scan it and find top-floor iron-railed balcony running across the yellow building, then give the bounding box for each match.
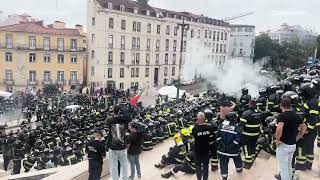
[0,43,86,52]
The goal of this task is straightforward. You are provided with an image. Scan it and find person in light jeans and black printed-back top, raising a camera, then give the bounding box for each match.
[107,105,130,180]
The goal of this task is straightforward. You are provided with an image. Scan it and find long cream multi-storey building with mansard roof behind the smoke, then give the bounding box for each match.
[87,0,230,89]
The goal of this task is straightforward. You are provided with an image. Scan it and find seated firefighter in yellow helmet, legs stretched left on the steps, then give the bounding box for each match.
[154,133,186,169]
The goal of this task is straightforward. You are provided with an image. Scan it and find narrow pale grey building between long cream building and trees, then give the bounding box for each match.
[229,25,256,63]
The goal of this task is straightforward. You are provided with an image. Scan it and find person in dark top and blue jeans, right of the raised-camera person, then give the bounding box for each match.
[128,123,143,179]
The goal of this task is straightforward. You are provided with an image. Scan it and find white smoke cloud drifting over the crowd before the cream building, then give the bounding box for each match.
[182,41,276,97]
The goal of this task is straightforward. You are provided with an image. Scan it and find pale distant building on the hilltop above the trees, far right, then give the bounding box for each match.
[266,23,317,43]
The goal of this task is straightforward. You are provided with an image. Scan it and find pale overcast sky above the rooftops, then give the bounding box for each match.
[0,0,320,32]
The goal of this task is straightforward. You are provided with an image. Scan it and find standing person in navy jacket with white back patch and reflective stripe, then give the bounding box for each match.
[217,112,242,180]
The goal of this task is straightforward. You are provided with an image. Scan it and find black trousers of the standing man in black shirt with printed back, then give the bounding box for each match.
[195,155,209,180]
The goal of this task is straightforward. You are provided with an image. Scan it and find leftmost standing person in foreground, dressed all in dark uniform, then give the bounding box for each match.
[86,132,106,180]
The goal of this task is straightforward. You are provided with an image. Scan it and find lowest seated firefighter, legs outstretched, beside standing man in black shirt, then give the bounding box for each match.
[161,150,196,179]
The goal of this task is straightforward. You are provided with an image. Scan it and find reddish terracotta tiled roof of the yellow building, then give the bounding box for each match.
[0,22,81,36]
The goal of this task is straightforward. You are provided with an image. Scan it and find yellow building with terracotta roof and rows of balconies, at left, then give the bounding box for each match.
[0,21,86,91]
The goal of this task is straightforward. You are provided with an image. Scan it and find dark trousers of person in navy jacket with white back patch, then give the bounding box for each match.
[219,154,242,177]
